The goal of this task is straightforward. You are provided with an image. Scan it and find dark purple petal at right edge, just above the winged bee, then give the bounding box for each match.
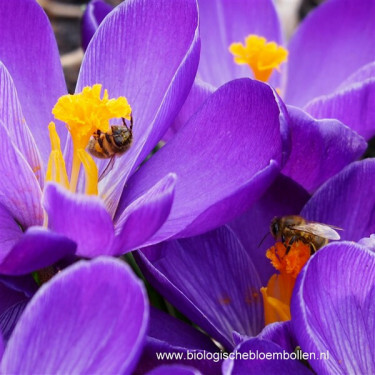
[301,159,375,241]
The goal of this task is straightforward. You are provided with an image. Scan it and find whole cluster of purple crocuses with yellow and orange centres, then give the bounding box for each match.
[0,0,375,374]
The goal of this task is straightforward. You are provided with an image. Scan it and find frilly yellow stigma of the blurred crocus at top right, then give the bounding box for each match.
[229,35,288,82]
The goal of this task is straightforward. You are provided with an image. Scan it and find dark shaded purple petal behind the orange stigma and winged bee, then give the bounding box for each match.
[229,175,310,285]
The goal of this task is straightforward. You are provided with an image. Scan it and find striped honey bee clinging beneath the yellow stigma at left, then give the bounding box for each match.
[87,116,133,159]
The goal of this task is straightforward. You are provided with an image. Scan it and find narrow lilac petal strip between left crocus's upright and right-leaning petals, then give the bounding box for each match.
[163,79,214,142]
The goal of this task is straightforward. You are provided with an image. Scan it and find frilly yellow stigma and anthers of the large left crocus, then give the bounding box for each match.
[46,84,132,194]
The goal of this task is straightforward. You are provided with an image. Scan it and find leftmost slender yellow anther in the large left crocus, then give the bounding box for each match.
[46,122,69,189]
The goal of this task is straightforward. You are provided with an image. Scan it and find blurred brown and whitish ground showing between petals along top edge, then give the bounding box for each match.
[37,0,324,93]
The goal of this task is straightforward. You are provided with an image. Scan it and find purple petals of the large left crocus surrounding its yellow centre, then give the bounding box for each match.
[0,0,288,274]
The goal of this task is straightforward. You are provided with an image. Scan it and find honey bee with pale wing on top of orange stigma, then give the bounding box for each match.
[270,215,342,254]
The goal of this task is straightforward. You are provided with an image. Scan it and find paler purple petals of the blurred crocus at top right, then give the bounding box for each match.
[194,0,375,192]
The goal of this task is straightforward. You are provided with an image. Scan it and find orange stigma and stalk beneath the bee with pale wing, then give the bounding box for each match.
[260,241,311,325]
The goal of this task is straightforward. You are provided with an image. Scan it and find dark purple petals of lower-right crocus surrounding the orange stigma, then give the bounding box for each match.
[137,159,375,374]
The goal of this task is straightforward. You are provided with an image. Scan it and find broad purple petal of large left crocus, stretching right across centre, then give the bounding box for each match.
[119,79,288,243]
